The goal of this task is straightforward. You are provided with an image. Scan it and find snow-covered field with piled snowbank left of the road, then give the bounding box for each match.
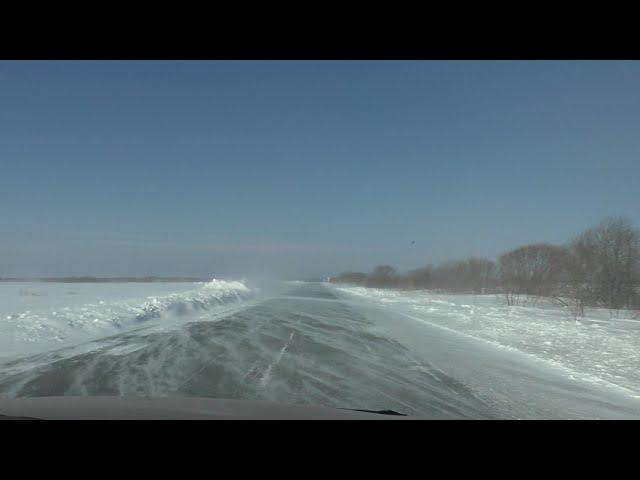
[0,280,255,359]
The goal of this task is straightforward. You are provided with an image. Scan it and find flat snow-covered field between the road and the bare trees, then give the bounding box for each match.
[336,286,640,398]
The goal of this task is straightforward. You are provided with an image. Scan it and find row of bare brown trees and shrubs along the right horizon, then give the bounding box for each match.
[331,217,640,314]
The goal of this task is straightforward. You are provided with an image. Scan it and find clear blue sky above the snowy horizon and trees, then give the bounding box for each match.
[0,61,640,277]
